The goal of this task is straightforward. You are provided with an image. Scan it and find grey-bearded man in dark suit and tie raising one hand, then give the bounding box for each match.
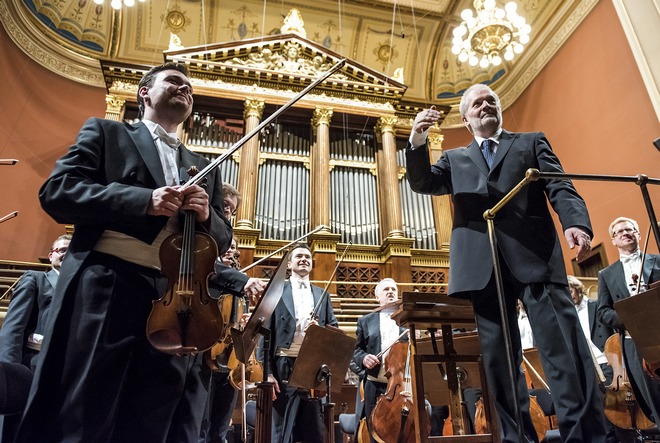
[406,84,605,443]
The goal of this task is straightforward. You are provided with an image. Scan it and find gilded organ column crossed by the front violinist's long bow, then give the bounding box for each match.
[236,99,265,228]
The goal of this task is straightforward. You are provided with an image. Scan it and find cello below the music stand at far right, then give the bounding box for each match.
[604,334,655,430]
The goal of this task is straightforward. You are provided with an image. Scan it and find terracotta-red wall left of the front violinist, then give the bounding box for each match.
[0,26,105,261]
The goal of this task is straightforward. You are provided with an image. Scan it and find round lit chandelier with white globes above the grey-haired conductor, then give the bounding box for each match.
[451,0,532,68]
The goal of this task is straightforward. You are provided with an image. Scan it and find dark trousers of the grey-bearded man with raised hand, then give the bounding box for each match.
[470,268,605,443]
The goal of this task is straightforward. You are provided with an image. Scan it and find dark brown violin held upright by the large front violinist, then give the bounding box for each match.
[147,166,224,355]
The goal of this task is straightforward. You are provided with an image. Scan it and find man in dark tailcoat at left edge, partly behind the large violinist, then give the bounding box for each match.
[0,234,71,441]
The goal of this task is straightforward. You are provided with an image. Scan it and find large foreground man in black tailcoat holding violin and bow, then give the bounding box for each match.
[16,63,232,442]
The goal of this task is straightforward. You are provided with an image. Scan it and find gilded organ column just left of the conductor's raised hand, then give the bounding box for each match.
[376,115,403,238]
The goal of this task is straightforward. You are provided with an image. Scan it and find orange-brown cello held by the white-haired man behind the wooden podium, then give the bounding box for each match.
[371,342,430,443]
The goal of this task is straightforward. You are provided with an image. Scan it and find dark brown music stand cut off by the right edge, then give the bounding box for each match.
[614,286,660,370]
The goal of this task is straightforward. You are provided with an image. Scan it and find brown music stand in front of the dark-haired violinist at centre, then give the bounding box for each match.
[289,325,356,443]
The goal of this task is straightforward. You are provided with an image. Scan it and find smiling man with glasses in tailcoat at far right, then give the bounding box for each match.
[598,217,660,432]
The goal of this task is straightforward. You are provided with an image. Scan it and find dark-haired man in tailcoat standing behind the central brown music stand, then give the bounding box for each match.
[266,243,339,443]
